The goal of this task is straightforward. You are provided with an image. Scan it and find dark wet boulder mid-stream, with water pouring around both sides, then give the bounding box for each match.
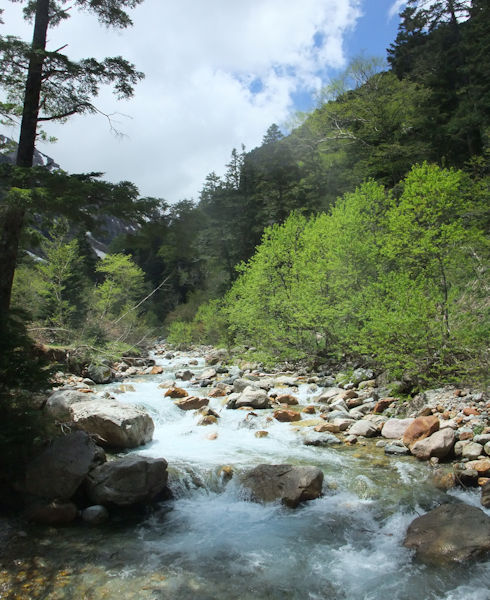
[242,465,323,508]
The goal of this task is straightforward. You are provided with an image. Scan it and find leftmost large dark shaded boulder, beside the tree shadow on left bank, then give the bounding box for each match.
[22,431,105,500]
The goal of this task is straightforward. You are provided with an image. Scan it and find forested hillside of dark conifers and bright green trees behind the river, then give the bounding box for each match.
[2,0,490,379]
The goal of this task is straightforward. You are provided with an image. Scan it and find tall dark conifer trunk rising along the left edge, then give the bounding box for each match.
[0,0,50,315]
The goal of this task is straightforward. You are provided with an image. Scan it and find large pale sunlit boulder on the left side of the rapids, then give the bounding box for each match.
[71,400,155,448]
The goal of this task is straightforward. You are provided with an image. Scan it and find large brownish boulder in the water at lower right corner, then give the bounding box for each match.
[403,504,490,564]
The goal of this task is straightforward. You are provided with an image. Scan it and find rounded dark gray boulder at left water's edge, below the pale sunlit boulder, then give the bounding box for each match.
[86,454,168,506]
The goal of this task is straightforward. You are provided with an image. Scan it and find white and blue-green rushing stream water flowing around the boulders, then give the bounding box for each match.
[0,354,490,600]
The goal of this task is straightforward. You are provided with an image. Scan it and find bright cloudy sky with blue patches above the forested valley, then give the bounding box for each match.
[0,0,405,203]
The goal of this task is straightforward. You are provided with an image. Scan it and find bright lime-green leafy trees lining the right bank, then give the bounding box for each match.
[187,163,489,380]
